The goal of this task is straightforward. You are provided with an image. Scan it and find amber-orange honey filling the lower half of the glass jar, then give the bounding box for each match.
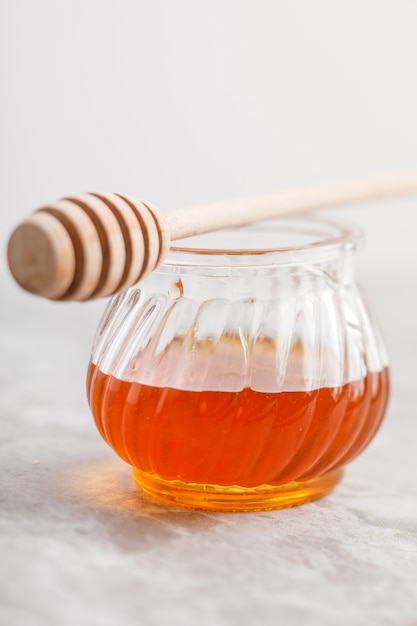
[87,363,389,511]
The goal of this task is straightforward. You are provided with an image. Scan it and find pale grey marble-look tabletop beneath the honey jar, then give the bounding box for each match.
[0,269,417,626]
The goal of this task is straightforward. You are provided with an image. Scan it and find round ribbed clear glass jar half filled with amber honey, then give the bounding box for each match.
[87,218,389,511]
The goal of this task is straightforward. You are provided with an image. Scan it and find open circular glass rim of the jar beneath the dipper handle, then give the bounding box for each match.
[164,216,364,265]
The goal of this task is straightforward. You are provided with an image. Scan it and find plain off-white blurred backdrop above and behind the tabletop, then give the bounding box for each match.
[0,0,417,366]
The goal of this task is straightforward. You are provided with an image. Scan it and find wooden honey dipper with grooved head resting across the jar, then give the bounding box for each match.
[8,171,417,301]
